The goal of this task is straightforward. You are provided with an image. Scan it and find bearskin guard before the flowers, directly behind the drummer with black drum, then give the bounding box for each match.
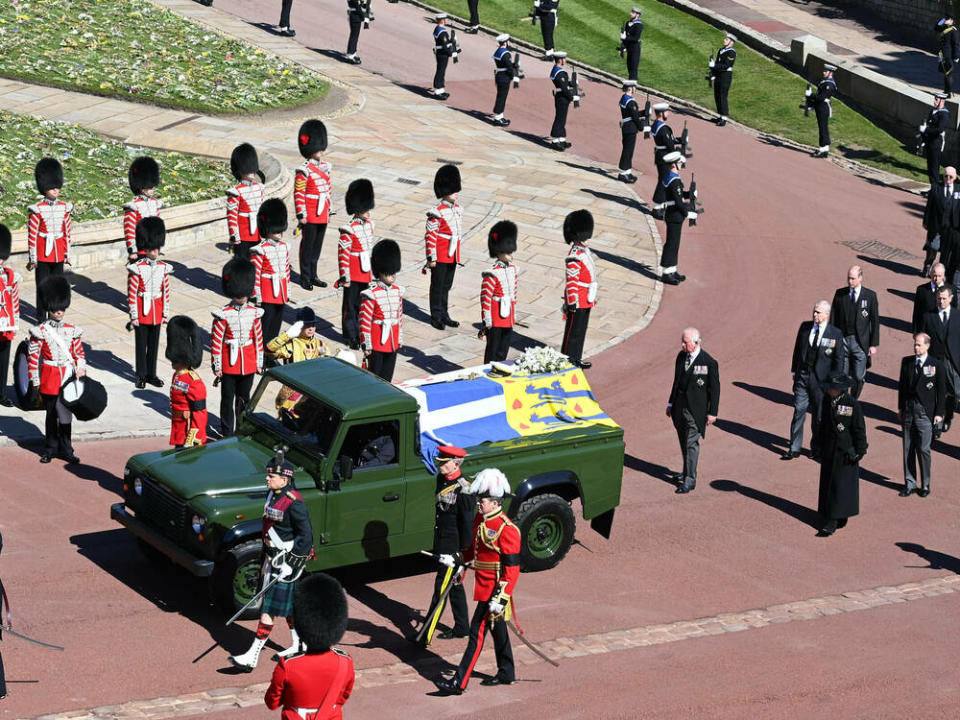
[27,157,73,322]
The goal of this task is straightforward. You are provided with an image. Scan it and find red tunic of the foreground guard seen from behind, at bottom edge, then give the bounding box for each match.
[263,648,354,720]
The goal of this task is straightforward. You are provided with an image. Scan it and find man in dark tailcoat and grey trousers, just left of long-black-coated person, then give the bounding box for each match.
[783,300,847,460]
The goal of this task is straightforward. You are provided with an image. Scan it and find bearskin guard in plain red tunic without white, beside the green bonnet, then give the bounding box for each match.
[165,315,207,449]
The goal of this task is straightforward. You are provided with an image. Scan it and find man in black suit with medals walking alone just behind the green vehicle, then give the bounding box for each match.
[667,327,720,493]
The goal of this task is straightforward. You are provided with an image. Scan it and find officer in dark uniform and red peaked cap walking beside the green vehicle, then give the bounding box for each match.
[421,445,477,647]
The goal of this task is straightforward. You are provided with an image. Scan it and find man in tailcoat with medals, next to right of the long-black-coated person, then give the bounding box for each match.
[897,333,946,497]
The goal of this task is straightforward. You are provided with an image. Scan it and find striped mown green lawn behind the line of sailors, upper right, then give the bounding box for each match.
[431,0,926,180]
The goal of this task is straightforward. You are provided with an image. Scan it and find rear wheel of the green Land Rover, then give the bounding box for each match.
[515,494,577,572]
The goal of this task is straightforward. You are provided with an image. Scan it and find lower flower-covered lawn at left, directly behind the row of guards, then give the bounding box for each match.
[0,111,233,230]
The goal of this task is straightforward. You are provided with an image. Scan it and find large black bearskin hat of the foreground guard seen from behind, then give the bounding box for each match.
[293,573,347,652]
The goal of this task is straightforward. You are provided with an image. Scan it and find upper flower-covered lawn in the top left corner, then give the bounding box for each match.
[0,0,328,113]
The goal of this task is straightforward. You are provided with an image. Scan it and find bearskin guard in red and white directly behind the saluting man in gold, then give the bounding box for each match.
[250,198,290,348]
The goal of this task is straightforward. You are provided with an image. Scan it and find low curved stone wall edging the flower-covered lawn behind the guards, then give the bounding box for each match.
[12,151,293,272]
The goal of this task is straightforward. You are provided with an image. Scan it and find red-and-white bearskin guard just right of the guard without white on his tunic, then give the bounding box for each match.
[210,257,263,437]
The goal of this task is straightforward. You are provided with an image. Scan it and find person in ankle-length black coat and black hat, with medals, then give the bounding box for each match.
[817,373,867,537]
